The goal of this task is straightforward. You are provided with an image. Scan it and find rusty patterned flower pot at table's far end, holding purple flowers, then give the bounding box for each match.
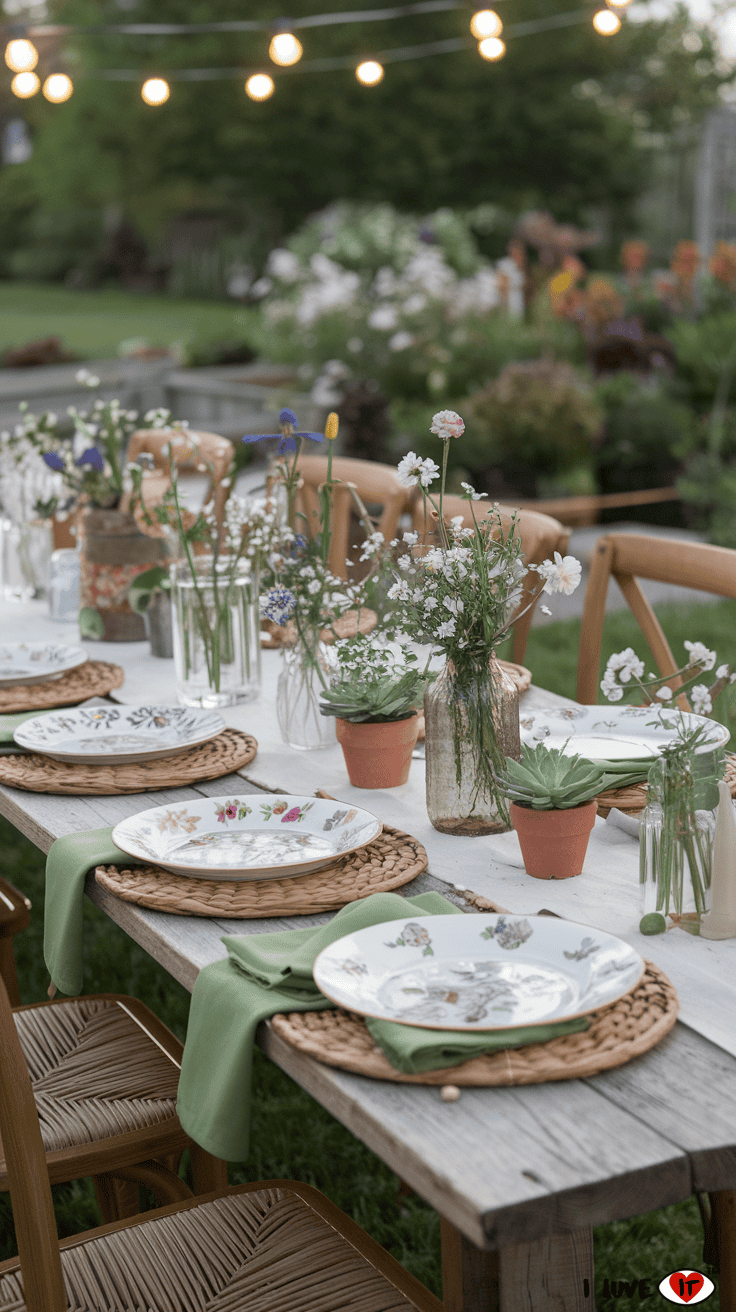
[79,510,168,643]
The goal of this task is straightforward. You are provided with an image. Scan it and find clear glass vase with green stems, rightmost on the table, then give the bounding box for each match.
[639,749,724,934]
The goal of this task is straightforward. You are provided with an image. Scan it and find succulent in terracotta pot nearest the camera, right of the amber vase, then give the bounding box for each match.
[500,743,605,879]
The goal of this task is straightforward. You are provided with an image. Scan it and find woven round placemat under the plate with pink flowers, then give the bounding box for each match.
[94,827,426,920]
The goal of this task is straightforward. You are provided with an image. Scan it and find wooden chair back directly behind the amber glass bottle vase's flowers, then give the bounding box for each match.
[413,496,571,663]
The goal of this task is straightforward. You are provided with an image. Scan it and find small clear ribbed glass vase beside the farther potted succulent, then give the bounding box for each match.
[277,634,337,750]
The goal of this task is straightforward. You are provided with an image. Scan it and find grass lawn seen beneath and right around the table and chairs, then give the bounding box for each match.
[0,601,736,1312]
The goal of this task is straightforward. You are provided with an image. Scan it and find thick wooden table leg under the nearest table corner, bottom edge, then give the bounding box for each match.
[441,1220,592,1312]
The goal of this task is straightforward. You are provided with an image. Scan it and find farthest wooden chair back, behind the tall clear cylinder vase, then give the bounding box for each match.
[121,428,234,529]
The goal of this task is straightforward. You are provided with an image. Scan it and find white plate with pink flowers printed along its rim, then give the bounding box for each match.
[113,792,383,879]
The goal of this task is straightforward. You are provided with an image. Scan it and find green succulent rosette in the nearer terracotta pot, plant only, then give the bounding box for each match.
[500,743,609,811]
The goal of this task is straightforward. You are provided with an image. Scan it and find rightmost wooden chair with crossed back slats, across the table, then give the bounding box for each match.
[576,533,736,705]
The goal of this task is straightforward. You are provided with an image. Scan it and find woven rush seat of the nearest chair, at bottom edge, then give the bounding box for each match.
[0,1187,417,1312]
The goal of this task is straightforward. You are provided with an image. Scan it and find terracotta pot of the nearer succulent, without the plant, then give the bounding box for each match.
[509,798,598,879]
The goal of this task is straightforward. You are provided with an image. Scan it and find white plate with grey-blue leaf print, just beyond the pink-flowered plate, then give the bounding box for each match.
[13,706,224,765]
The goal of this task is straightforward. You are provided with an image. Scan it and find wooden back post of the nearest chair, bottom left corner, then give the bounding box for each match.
[0,979,68,1312]
